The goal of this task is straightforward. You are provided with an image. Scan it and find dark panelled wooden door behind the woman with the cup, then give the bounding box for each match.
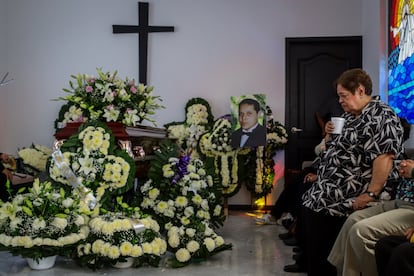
[285,36,362,170]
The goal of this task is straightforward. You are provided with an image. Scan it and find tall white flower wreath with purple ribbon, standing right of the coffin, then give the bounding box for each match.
[140,141,231,267]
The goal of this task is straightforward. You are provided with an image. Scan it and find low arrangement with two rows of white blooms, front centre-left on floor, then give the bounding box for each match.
[75,212,167,269]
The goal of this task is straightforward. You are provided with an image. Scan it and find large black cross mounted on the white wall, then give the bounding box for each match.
[112,2,174,84]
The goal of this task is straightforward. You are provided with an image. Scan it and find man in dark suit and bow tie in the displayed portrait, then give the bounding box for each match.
[230,98,266,148]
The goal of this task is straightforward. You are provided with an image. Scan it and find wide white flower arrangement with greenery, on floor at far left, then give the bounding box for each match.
[0,179,90,260]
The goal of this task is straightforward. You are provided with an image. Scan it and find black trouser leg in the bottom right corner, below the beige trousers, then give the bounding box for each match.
[375,236,414,276]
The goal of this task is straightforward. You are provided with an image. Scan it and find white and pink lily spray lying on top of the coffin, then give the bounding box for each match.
[55,68,164,130]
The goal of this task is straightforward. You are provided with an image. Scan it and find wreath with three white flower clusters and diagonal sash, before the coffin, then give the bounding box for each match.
[48,121,136,212]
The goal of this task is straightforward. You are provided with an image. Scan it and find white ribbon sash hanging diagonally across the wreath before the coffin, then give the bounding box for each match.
[52,150,98,210]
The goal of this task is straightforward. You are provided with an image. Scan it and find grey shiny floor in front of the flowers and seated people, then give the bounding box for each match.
[0,211,306,276]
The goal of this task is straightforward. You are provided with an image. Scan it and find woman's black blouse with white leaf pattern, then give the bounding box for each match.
[303,96,404,216]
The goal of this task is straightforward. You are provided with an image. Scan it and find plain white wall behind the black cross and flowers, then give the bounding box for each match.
[0,0,385,205]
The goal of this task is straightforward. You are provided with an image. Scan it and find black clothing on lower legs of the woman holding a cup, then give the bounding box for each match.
[302,207,346,276]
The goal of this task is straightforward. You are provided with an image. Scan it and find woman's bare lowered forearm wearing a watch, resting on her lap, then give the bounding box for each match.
[353,153,394,210]
